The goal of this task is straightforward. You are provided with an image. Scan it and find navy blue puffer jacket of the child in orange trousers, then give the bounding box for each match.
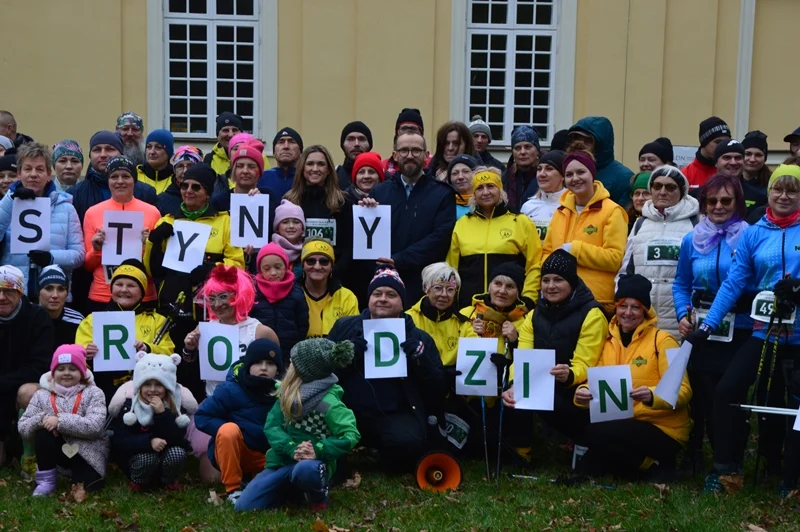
[194,362,278,463]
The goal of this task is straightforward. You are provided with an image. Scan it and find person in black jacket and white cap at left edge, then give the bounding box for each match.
[0,266,55,464]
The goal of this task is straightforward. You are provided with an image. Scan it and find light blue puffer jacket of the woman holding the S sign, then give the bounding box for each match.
[0,181,86,301]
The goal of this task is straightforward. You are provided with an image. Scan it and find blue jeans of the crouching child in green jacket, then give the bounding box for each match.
[236,460,328,512]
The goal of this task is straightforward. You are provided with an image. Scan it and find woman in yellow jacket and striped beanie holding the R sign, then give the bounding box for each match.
[75,259,175,401]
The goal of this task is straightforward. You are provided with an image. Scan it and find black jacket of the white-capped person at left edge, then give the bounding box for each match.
[0,296,54,392]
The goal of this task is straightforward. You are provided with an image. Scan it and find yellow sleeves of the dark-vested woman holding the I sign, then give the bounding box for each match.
[509,302,608,386]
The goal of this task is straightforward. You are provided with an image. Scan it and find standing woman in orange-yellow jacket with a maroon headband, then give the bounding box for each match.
[542,152,628,314]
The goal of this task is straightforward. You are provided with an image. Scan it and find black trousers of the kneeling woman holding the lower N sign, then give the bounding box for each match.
[579,419,681,474]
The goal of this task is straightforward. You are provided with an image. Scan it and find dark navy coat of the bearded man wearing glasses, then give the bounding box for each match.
[370,174,456,307]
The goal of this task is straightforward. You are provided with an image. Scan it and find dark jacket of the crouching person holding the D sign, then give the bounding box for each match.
[328,310,447,426]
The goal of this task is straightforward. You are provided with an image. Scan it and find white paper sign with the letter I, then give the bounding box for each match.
[514,349,556,411]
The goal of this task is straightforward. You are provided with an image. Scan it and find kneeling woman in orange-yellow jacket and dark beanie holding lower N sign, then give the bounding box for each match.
[575,274,692,479]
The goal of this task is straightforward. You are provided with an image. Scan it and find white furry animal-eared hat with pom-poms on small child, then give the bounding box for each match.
[122,351,189,428]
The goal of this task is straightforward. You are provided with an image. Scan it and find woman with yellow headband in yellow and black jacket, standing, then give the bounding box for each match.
[447,167,542,310]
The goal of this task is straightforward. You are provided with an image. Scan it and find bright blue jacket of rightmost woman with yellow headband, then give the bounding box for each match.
[706,216,800,345]
